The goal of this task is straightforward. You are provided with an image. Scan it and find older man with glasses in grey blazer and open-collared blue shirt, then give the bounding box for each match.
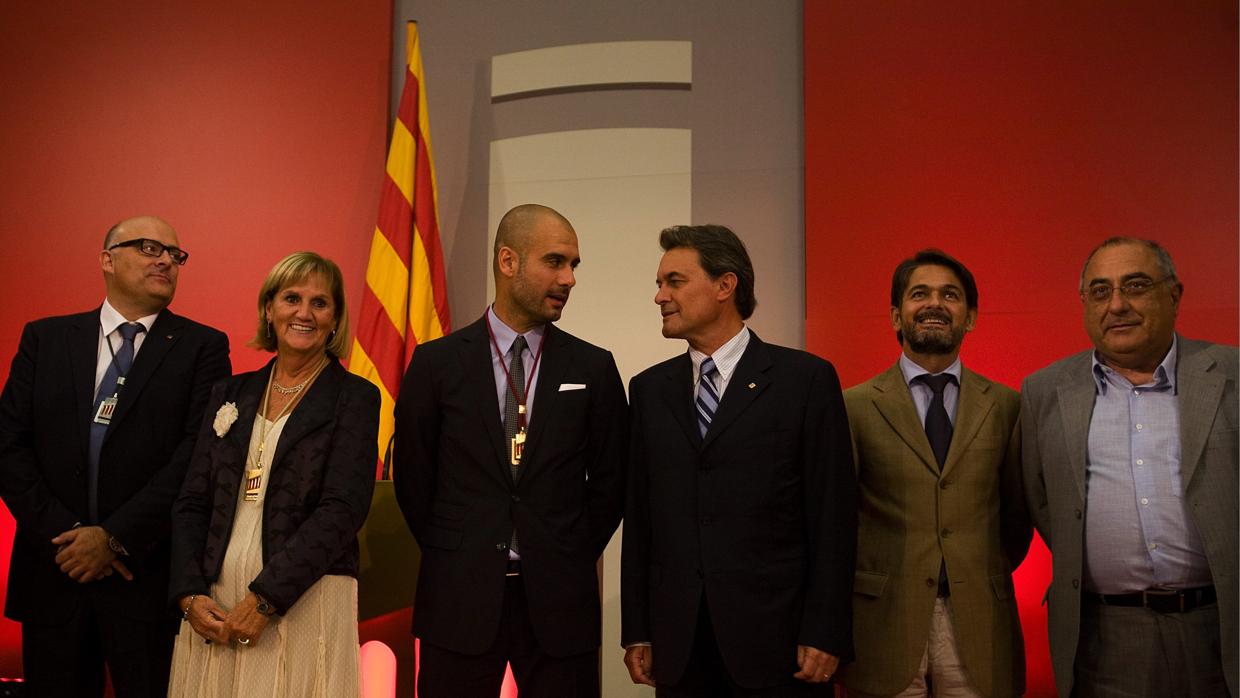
[1021,238,1240,698]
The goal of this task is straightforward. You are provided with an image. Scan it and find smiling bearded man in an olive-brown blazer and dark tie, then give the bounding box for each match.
[841,250,1032,698]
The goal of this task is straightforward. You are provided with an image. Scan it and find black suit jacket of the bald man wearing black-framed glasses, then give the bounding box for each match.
[0,309,229,622]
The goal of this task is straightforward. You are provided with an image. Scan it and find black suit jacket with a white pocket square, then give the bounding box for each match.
[393,319,627,656]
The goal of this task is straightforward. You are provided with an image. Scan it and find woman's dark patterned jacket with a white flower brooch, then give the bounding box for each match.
[170,360,379,614]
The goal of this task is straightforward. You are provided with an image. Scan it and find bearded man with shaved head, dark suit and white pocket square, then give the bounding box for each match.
[394,205,627,698]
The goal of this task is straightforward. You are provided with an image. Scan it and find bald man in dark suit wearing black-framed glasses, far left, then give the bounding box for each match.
[0,217,229,698]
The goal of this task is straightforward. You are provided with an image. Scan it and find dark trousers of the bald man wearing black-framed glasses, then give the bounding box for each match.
[21,601,176,698]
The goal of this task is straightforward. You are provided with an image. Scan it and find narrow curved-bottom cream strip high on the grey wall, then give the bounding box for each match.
[491,41,693,99]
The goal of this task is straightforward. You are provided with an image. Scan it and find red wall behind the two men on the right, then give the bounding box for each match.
[805,0,1238,696]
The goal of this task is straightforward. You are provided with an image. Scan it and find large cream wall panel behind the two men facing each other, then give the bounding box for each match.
[485,129,691,697]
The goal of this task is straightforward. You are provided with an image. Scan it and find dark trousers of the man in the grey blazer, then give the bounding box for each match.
[1073,601,1229,698]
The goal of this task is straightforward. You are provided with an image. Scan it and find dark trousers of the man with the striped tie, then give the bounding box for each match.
[653,598,833,698]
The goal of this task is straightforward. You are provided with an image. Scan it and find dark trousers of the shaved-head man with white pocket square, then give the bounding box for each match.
[414,577,600,698]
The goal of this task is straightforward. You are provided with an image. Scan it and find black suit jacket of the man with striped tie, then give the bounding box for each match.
[621,335,857,688]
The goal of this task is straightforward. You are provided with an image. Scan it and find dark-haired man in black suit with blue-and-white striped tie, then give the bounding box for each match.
[621,226,857,698]
